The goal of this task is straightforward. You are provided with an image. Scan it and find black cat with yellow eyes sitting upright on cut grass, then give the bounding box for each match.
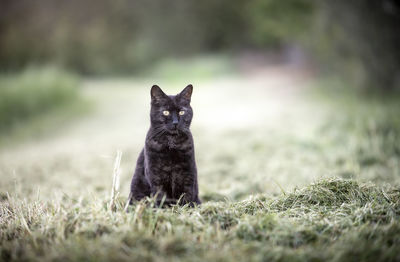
[130,85,201,206]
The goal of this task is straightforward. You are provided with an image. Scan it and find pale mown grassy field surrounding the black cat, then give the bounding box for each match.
[0,61,400,261]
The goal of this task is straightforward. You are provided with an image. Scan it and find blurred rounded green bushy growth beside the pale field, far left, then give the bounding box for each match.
[0,68,78,132]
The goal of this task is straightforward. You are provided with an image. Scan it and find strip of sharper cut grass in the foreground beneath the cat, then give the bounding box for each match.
[0,179,400,261]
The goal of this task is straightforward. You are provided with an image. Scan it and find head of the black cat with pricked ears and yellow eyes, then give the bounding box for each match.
[150,85,193,135]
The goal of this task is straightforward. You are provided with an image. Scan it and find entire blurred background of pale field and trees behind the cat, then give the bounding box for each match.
[0,0,400,200]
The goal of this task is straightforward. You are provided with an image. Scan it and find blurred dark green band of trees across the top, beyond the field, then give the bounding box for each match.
[0,0,400,90]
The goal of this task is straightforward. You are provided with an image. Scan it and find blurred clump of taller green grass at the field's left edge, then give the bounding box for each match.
[0,67,88,144]
